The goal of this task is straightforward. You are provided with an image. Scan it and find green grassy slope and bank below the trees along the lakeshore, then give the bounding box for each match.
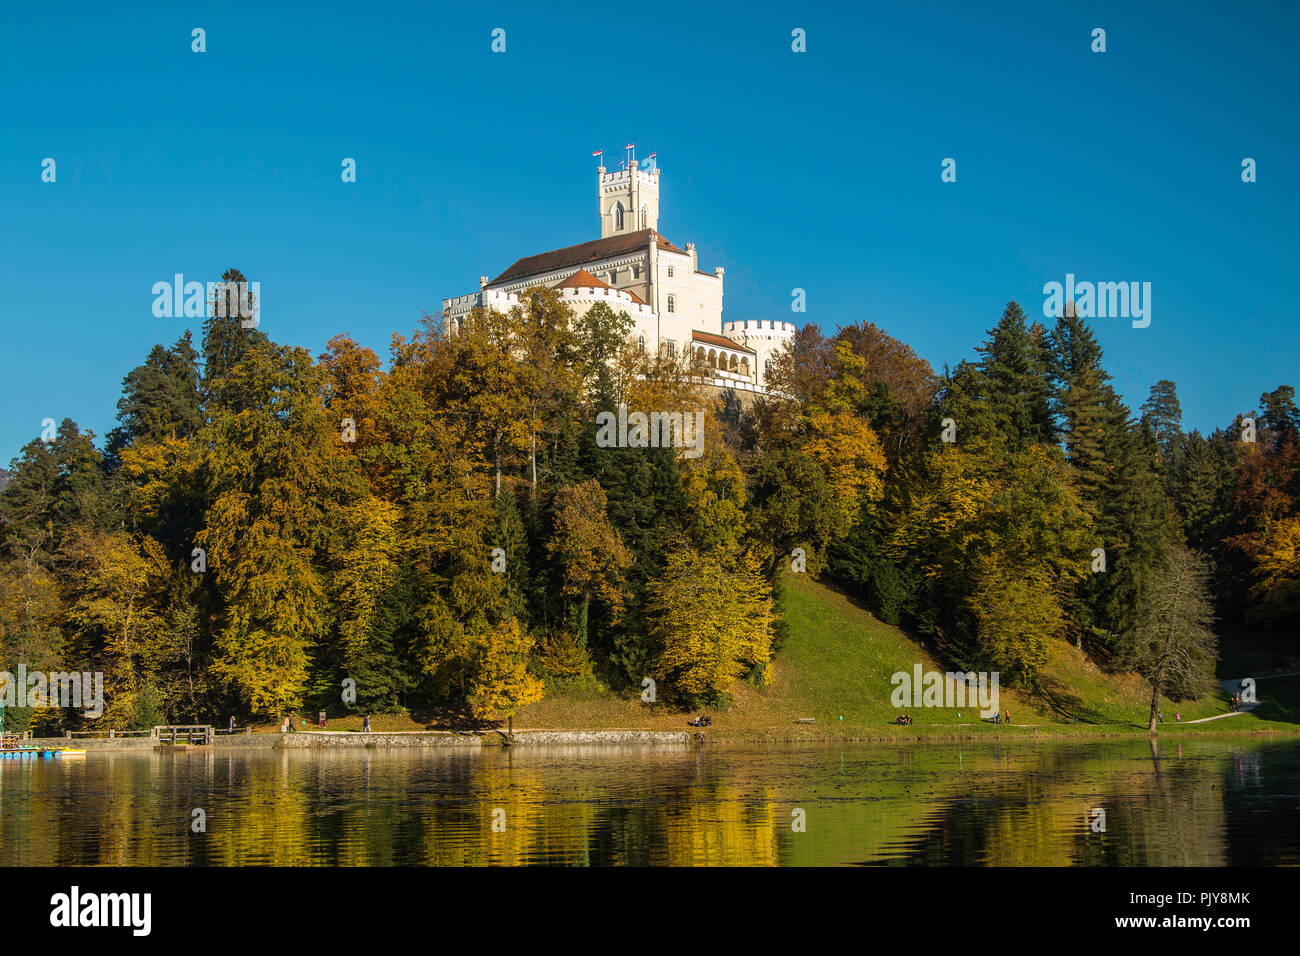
[319,575,1300,740]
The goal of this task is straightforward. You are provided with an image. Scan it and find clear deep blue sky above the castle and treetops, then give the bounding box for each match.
[0,0,1300,462]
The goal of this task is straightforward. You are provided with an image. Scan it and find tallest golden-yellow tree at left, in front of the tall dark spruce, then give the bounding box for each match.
[196,346,364,714]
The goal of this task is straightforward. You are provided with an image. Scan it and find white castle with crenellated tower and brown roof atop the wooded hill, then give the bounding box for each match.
[442,151,794,393]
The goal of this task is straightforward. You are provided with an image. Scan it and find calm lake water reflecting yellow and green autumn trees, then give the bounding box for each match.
[0,739,1300,866]
